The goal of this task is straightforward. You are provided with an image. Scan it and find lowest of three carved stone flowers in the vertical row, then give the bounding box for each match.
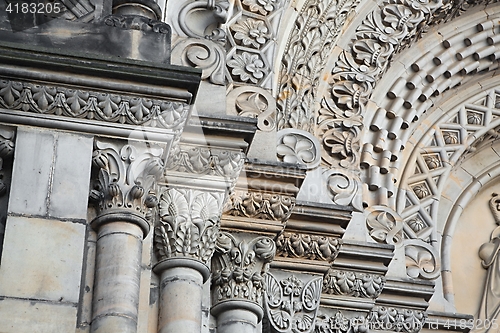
[227,52,267,83]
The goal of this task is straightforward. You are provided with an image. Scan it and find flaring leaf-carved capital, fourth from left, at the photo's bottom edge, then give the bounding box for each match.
[265,274,322,333]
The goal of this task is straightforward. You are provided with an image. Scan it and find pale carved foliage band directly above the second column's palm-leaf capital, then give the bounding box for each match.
[166,144,245,181]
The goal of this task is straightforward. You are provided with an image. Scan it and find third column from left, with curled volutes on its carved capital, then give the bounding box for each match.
[212,232,276,333]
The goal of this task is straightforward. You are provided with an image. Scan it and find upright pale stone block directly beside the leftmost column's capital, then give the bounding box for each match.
[49,132,93,219]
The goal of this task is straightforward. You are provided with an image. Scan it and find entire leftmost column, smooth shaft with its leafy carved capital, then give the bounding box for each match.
[91,141,163,333]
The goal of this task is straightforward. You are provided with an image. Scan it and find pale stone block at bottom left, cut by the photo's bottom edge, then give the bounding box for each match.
[0,298,76,333]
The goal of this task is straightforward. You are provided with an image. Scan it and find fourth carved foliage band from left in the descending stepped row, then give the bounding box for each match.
[323,269,385,299]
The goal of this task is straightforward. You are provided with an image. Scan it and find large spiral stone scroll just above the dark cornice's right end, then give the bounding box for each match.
[172,38,225,85]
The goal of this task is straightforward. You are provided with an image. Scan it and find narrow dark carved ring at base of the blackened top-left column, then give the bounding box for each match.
[103,15,172,36]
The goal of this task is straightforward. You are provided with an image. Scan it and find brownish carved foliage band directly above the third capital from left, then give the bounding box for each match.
[227,191,295,221]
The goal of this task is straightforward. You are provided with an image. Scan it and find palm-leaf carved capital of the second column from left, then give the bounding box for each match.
[154,188,223,265]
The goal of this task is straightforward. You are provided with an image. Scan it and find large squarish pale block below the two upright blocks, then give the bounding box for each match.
[0,216,86,302]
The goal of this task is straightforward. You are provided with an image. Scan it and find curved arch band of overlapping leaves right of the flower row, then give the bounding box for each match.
[277,0,359,133]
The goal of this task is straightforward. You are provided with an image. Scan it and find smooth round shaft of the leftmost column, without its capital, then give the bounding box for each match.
[92,222,143,333]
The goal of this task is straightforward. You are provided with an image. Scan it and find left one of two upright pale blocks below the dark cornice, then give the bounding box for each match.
[9,128,55,215]
